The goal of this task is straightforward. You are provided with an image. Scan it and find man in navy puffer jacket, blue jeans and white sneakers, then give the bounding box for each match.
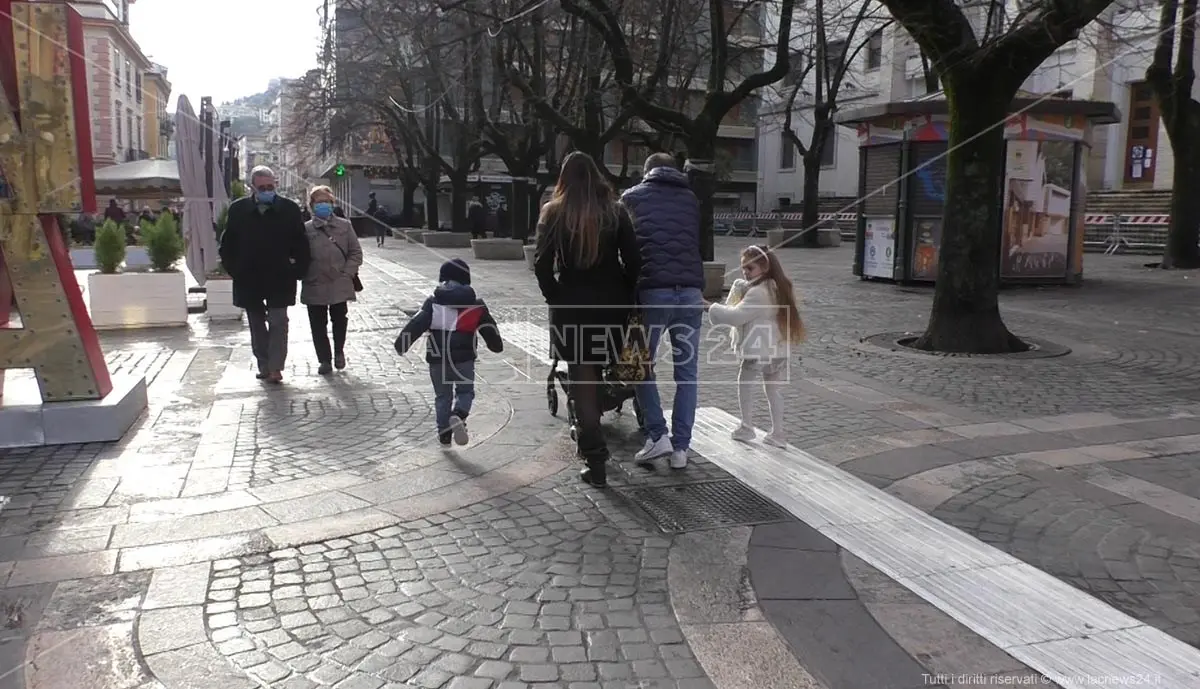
[620,154,704,469]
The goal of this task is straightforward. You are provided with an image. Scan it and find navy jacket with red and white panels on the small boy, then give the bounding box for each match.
[395,282,504,364]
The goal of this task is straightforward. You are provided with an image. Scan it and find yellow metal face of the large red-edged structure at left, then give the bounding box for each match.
[0,2,102,402]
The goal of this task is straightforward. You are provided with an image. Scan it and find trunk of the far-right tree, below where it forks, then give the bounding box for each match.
[1162,109,1200,269]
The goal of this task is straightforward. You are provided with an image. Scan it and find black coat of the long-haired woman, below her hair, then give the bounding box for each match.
[534,205,642,366]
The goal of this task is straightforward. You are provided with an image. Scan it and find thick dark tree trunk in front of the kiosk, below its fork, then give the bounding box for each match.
[916,84,1028,354]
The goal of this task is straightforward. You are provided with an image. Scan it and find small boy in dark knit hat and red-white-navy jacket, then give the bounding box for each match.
[395,258,504,445]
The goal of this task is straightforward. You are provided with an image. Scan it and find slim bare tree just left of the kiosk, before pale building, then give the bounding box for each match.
[778,0,890,246]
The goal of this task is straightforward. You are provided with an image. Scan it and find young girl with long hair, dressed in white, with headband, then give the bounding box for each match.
[708,245,804,448]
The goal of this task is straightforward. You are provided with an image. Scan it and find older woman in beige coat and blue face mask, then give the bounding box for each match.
[300,186,362,376]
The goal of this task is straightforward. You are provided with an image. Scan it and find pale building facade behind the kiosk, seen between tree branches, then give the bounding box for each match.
[758,0,1185,211]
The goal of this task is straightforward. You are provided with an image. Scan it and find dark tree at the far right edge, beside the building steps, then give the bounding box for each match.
[1146,0,1200,269]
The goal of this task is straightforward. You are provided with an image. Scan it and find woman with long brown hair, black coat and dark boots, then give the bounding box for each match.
[534,151,641,487]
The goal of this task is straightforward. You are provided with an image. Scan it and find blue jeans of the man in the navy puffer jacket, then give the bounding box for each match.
[636,287,704,450]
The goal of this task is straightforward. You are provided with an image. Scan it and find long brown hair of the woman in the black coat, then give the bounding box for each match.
[538,151,617,268]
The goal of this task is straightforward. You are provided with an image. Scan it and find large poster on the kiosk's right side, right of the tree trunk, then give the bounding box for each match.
[1000,140,1075,278]
